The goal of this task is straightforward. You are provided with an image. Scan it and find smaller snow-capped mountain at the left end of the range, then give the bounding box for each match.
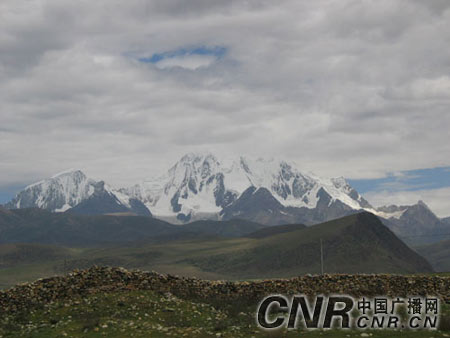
[5,169,148,214]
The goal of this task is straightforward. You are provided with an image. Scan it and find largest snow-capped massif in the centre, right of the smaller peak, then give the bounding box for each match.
[121,153,373,223]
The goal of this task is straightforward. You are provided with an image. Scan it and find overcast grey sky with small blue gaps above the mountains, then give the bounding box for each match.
[0,0,450,216]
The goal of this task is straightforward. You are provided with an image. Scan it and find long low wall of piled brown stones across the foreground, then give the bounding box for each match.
[0,267,450,315]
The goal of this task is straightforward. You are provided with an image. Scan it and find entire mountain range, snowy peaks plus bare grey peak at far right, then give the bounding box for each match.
[5,152,450,243]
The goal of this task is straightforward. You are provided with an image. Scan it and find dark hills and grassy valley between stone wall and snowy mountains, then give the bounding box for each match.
[0,209,440,288]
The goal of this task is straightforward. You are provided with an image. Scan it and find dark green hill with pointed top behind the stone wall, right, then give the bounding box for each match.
[186,213,433,278]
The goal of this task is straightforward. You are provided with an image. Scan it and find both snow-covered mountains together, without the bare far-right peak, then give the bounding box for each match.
[8,152,372,222]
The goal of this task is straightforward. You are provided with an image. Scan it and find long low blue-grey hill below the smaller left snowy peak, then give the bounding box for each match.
[0,208,264,246]
